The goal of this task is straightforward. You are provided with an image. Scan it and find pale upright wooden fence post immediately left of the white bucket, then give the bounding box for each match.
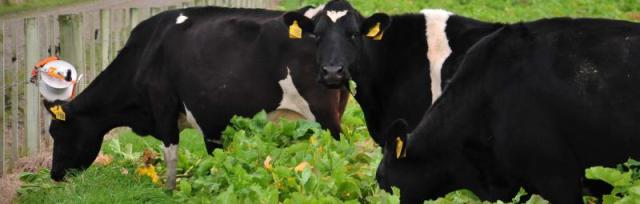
[23,18,40,155]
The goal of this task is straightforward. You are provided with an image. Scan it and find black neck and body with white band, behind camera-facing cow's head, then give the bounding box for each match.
[354,11,501,144]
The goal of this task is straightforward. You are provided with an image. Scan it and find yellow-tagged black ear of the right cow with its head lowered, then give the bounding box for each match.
[383,119,409,159]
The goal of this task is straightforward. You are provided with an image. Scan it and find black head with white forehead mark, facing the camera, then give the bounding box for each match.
[284,0,391,88]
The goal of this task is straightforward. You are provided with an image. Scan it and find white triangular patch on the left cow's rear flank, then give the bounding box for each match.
[277,67,316,121]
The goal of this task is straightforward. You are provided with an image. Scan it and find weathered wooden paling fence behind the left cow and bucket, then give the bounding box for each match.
[0,0,278,176]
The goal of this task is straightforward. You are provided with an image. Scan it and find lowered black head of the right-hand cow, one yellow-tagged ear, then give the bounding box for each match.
[376,119,450,203]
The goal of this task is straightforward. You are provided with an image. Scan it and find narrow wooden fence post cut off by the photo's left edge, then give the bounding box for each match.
[0,21,7,176]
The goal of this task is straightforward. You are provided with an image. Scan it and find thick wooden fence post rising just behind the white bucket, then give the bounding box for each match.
[58,14,86,92]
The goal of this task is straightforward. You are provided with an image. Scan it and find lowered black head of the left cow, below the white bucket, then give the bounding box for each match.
[44,101,102,181]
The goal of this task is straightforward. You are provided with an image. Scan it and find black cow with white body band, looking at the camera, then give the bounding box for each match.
[284,0,502,145]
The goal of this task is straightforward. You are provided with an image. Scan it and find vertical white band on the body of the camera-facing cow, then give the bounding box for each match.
[421,9,452,104]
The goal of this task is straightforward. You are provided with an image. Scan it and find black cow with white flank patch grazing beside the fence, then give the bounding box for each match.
[44,7,348,188]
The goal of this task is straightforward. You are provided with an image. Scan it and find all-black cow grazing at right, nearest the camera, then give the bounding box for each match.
[377,18,640,203]
